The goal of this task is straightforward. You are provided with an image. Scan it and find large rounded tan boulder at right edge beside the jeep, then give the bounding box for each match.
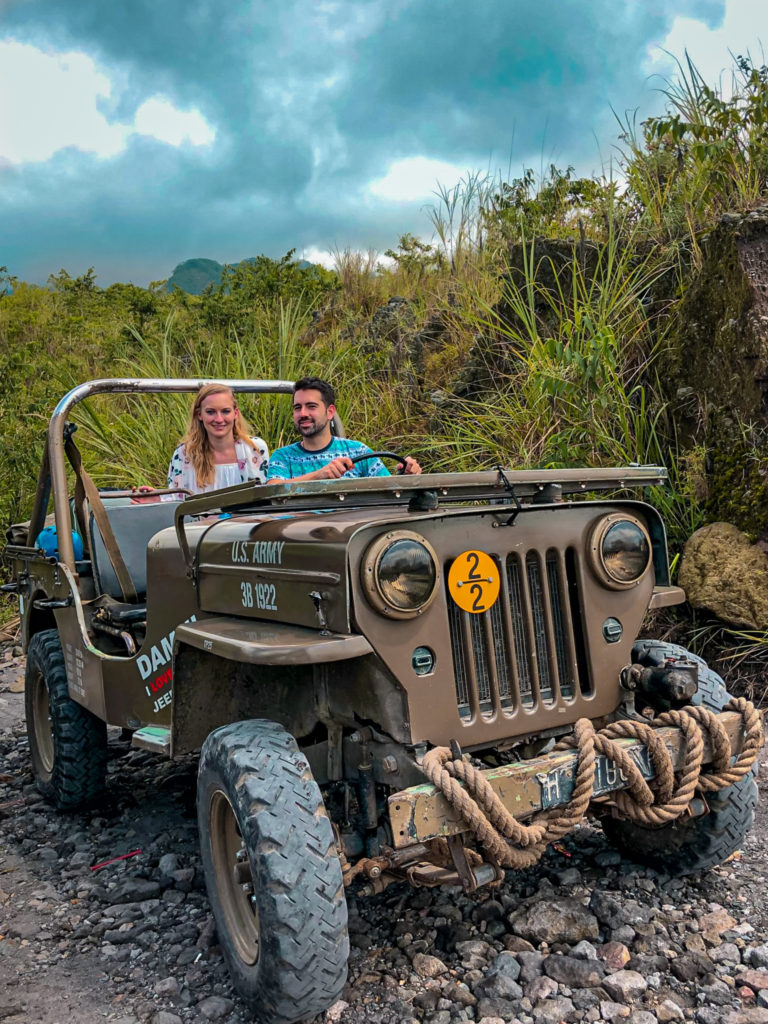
[678,522,768,630]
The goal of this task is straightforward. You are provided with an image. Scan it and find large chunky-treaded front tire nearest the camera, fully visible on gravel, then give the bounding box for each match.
[198,721,349,1024]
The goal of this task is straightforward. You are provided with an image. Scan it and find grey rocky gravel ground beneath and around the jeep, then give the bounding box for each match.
[0,648,768,1024]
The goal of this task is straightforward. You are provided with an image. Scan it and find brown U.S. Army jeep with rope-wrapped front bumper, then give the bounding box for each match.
[4,380,762,1024]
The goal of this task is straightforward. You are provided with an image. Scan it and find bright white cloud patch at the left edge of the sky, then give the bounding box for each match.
[0,39,215,164]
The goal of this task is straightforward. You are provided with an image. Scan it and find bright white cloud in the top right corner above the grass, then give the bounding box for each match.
[647,0,768,84]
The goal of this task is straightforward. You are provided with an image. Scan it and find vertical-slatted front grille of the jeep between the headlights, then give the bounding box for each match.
[445,550,590,720]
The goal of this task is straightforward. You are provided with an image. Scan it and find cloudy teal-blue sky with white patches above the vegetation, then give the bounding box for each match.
[0,0,768,286]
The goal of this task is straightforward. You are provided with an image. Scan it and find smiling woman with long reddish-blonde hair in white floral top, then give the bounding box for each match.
[168,384,269,495]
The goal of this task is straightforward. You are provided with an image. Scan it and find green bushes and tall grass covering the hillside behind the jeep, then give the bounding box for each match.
[0,51,768,630]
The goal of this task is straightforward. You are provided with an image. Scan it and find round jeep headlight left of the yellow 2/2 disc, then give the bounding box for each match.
[360,529,438,618]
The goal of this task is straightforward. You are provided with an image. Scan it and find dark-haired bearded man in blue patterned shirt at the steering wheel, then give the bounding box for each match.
[266,377,421,483]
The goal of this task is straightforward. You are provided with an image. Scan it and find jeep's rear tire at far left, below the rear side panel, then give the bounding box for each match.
[25,630,106,811]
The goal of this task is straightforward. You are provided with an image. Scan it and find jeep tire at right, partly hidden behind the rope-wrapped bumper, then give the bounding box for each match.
[602,641,758,876]
